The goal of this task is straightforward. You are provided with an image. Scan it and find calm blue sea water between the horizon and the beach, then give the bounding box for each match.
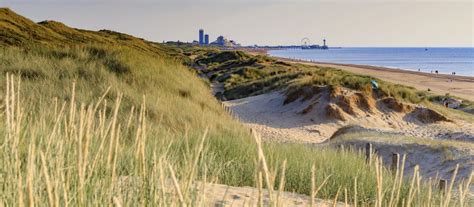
[269,47,474,76]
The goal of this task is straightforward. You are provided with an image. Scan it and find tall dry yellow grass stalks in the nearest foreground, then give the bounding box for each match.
[0,75,472,206]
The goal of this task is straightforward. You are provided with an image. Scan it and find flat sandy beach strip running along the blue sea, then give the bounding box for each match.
[243,49,474,101]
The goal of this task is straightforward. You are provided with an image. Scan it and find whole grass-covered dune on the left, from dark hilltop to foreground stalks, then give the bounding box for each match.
[0,9,472,206]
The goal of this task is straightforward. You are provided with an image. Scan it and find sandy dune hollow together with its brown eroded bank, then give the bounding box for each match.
[224,91,474,143]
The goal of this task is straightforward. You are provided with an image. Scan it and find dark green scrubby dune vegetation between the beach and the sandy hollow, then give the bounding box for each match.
[193,50,474,116]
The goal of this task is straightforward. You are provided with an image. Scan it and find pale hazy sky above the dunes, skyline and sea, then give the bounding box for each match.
[0,0,474,47]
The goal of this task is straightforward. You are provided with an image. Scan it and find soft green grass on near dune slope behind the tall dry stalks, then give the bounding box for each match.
[0,46,400,204]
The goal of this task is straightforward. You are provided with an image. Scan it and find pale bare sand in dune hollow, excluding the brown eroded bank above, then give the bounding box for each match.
[224,92,474,143]
